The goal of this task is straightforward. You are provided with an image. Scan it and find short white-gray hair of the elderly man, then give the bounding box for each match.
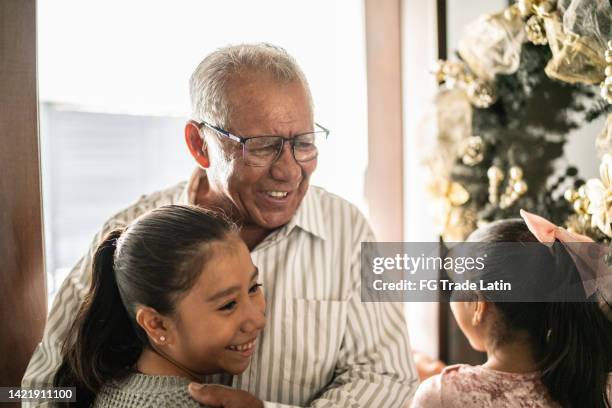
[189,43,312,127]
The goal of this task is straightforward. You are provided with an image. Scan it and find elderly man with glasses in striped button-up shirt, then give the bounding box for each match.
[23,44,418,407]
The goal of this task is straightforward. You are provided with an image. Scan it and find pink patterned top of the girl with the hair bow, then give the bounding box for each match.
[412,364,612,408]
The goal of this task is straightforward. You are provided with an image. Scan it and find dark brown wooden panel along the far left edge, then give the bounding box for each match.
[0,0,46,386]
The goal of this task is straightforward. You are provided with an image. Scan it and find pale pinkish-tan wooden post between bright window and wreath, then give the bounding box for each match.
[365,0,404,241]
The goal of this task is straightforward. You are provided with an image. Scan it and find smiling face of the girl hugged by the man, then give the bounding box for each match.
[165,236,266,375]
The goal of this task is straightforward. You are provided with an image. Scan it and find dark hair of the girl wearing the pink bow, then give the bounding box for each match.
[470,219,612,408]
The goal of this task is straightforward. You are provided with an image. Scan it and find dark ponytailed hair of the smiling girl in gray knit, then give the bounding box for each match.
[54,205,236,406]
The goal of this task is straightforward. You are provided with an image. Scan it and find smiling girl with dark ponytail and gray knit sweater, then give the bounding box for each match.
[55,205,265,408]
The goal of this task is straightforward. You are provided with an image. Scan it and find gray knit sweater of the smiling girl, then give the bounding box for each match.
[94,373,202,408]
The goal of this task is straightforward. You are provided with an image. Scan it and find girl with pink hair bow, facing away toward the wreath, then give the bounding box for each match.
[412,211,612,408]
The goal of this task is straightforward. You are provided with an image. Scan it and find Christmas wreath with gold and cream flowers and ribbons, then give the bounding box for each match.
[426,0,612,242]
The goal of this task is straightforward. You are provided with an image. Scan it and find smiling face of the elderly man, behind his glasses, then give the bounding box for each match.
[207,74,317,230]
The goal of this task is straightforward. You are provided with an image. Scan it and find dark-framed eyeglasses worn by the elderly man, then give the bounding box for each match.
[198,121,329,167]
